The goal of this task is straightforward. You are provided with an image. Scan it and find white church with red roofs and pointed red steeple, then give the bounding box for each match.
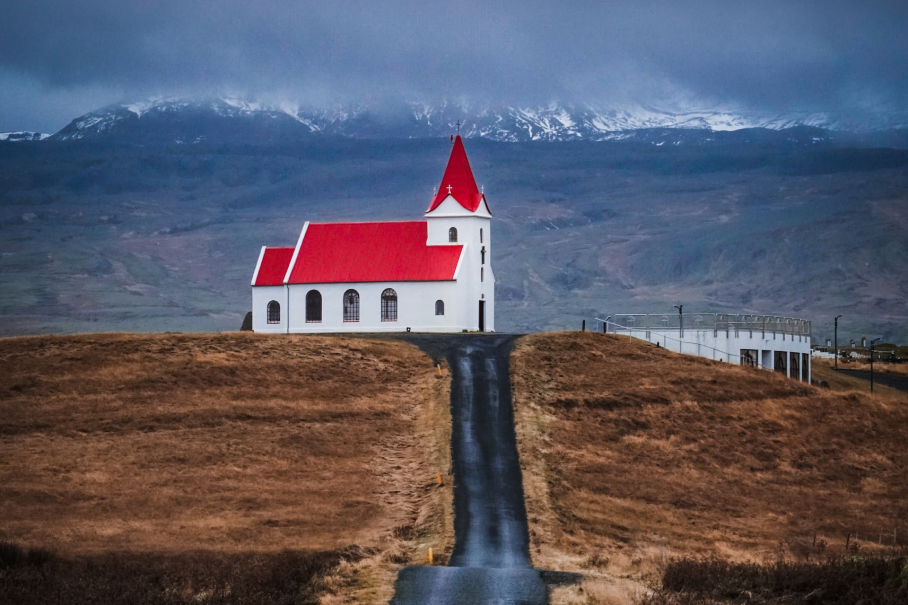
[252,134,495,333]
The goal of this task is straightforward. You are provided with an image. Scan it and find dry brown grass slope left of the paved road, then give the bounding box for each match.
[0,334,453,602]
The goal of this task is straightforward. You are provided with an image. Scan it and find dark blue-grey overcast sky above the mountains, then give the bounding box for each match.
[0,0,908,132]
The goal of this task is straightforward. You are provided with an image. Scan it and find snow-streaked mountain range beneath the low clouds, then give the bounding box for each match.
[51,98,908,144]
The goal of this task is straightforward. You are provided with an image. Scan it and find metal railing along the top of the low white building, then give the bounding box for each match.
[599,313,810,336]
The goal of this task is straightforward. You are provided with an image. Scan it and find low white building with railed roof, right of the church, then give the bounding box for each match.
[600,313,810,382]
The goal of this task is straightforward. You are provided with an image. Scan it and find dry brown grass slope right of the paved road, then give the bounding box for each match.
[511,333,908,602]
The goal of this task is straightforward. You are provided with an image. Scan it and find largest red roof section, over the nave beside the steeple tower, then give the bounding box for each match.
[288,221,463,284]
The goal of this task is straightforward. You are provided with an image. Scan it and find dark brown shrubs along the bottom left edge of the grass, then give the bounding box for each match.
[0,543,362,605]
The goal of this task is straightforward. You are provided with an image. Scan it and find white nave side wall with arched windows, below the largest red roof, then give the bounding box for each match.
[289,281,464,332]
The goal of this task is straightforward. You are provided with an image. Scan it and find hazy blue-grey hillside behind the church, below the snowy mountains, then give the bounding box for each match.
[0,138,908,342]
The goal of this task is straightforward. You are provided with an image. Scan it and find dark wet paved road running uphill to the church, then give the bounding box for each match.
[391,334,548,605]
